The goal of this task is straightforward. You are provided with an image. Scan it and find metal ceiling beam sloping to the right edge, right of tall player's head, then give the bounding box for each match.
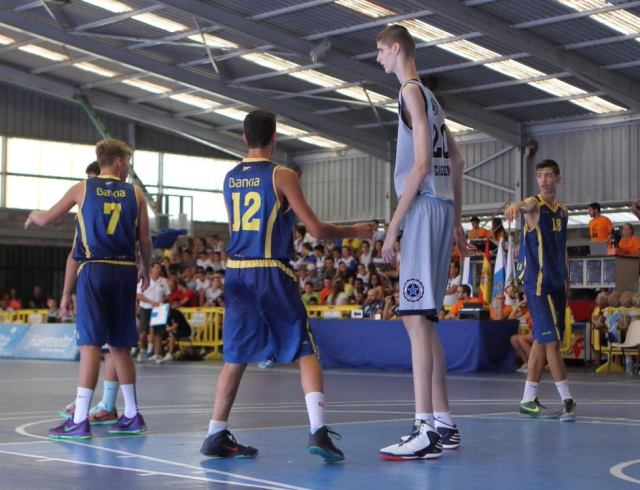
[423,0,640,110]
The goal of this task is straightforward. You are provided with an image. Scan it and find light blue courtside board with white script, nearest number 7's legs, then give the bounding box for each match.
[13,324,79,361]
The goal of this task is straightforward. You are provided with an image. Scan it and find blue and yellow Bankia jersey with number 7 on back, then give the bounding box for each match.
[73,176,139,262]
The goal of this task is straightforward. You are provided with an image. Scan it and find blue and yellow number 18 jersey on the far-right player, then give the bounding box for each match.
[518,195,568,296]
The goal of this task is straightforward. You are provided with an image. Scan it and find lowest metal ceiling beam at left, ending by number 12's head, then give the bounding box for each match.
[0,65,274,161]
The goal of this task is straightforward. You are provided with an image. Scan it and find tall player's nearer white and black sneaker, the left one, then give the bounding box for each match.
[379,419,442,461]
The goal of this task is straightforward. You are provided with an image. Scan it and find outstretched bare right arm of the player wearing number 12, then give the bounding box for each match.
[275,167,375,240]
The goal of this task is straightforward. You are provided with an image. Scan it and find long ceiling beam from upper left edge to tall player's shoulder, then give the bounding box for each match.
[0,10,389,159]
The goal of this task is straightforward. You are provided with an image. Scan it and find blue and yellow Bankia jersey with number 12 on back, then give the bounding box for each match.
[224,158,295,260]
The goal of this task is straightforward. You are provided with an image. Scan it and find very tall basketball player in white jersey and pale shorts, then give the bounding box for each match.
[377,25,473,460]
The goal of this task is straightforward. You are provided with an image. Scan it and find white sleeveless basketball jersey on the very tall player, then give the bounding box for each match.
[394,80,453,202]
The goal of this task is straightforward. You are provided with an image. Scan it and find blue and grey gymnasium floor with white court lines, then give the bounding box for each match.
[0,360,640,490]
